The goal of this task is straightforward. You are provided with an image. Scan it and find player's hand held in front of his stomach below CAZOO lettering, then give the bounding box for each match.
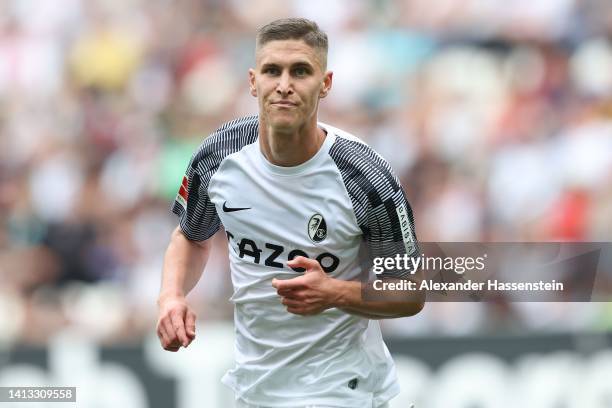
[272,256,338,316]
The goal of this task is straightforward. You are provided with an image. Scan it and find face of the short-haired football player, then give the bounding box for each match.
[249,40,332,132]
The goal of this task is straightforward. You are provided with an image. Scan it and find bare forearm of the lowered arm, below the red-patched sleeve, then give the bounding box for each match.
[159,228,210,300]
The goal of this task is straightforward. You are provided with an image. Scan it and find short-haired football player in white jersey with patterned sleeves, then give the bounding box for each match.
[157,19,423,408]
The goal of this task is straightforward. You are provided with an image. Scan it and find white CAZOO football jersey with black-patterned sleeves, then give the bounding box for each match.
[173,116,416,408]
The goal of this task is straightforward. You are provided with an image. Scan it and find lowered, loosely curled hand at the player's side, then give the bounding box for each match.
[157,297,196,352]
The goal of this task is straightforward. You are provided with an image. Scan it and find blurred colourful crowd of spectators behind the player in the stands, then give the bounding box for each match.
[0,0,612,344]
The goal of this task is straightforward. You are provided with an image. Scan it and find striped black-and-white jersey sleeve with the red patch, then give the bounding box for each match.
[172,116,259,241]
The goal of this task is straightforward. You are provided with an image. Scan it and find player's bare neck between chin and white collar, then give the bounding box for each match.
[259,116,325,167]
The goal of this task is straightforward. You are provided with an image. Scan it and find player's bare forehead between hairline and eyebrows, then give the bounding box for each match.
[255,40,321,66]
